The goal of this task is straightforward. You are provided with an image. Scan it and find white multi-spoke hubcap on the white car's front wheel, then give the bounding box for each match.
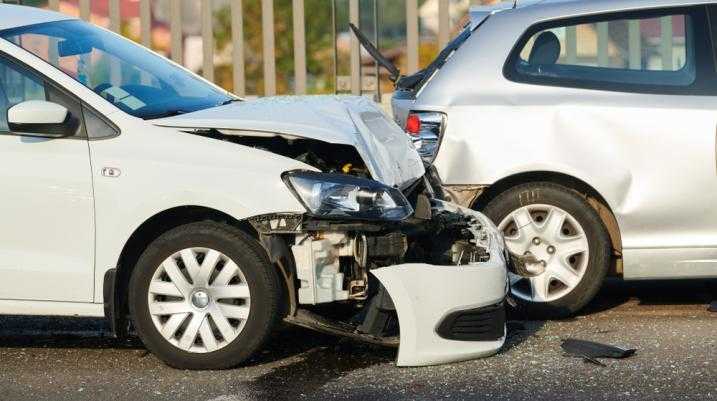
[147,248,251,353]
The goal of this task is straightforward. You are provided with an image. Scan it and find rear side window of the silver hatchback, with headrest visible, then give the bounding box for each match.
[507,10,699,92]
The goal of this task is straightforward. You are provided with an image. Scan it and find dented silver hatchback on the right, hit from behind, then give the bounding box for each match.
[386,0,717,316]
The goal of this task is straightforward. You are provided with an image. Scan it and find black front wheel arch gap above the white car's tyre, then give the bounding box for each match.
[104,206,286,337]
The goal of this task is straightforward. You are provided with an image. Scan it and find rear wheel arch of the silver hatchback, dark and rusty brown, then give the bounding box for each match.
[471,171,622,275]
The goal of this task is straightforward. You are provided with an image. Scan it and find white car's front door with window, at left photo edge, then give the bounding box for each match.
[0,54,94,302]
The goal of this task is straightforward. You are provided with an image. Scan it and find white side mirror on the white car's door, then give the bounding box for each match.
[7,100,77,138]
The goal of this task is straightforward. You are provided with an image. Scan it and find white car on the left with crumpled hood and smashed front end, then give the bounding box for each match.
[0,5,508,369]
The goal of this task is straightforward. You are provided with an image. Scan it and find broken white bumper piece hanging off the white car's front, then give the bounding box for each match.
[372,252,508,366]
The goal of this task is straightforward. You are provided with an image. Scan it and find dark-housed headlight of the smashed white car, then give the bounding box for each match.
[282,171,413,221]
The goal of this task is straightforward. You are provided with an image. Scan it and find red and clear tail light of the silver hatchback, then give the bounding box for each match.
[405,111,446,162]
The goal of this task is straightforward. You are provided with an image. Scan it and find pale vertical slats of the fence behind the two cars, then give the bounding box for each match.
[28,0,458,96]
